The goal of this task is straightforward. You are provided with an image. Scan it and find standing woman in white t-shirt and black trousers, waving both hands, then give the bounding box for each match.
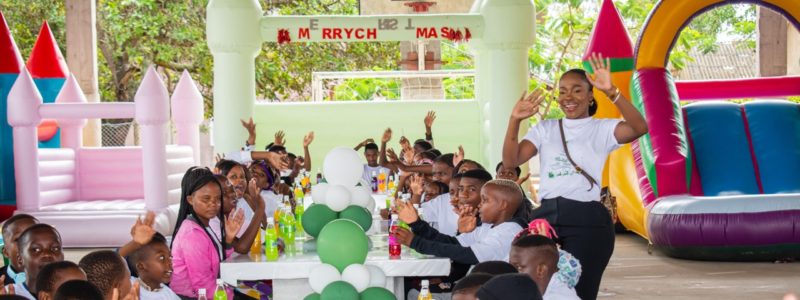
[503,53,647,300]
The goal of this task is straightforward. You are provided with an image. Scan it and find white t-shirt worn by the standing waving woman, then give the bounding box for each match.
[525,118,621,202]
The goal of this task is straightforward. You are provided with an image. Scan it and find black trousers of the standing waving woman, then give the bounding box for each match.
[533,197,614,300]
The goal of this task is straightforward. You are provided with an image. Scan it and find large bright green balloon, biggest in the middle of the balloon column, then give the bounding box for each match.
[317,219,369,272]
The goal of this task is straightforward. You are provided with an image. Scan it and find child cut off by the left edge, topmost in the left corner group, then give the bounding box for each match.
[0,214,39,285]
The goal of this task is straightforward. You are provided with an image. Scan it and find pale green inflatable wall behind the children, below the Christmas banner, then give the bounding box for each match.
[253,100,484,176]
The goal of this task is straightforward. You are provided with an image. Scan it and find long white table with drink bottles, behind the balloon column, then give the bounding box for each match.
[220,230,450,300]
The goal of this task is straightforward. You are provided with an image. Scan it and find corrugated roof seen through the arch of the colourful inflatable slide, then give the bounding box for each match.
[674,43,756,80]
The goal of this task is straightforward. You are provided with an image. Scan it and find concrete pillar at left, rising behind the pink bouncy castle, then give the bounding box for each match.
[62,0,102,147]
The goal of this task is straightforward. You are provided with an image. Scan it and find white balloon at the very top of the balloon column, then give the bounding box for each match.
[322,147,364,187]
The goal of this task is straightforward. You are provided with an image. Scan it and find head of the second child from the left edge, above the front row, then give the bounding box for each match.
[17,228,64,280]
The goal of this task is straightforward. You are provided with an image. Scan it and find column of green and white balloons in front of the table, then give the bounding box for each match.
[303,147,396,300]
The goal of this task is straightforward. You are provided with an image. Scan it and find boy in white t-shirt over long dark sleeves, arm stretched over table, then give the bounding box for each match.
[395,178,523,265]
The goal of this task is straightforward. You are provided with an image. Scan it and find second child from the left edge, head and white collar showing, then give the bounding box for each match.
[14,224,64,299]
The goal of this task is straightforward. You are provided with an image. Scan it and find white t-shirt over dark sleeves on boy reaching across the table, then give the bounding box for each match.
[456,222,522,262]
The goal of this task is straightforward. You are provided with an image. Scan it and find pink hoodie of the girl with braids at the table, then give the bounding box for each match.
[169,220,233,299]
